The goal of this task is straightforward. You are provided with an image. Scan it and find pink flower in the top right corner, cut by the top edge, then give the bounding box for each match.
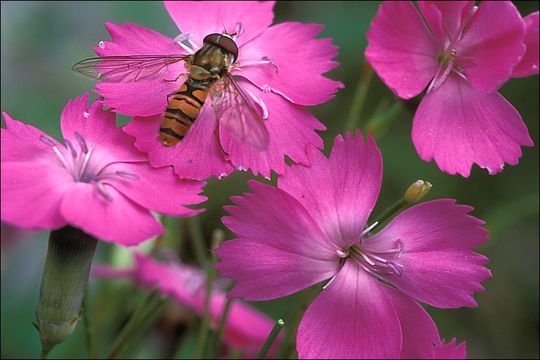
[365,1,538,177]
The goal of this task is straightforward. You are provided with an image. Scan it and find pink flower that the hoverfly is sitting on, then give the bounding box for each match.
[88,1,343,179]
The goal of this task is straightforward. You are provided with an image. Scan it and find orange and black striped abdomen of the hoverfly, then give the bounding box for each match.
[159,79,208,146]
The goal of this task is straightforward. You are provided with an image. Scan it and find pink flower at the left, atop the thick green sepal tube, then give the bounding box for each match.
[2,94,205,245]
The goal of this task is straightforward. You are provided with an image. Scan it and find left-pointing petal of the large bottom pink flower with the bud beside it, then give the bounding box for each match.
[216,181,339,300]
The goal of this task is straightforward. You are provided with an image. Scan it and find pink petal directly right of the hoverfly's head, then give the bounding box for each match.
[236,22,343,105]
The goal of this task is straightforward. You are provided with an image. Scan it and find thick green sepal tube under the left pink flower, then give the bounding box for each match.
[35,226,97,358]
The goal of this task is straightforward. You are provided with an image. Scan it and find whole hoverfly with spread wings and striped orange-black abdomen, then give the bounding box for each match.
[72,32,269,150]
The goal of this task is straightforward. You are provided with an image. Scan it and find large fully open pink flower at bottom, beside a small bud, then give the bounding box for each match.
[216,132,491,358]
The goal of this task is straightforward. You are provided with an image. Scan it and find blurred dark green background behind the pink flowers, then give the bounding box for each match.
[1,1,539,358]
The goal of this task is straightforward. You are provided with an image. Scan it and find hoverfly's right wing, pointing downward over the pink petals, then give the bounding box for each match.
[211,73,270,151]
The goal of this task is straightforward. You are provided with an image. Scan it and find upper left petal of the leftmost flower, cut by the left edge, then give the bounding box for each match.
[0,113,56,163]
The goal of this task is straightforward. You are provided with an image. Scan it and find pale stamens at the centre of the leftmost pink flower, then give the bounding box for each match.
[39,132,139,201]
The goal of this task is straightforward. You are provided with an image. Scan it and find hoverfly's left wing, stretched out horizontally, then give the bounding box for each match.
[71,55,189,82]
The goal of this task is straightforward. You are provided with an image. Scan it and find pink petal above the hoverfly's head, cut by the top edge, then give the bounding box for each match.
[165,1,274,46]
